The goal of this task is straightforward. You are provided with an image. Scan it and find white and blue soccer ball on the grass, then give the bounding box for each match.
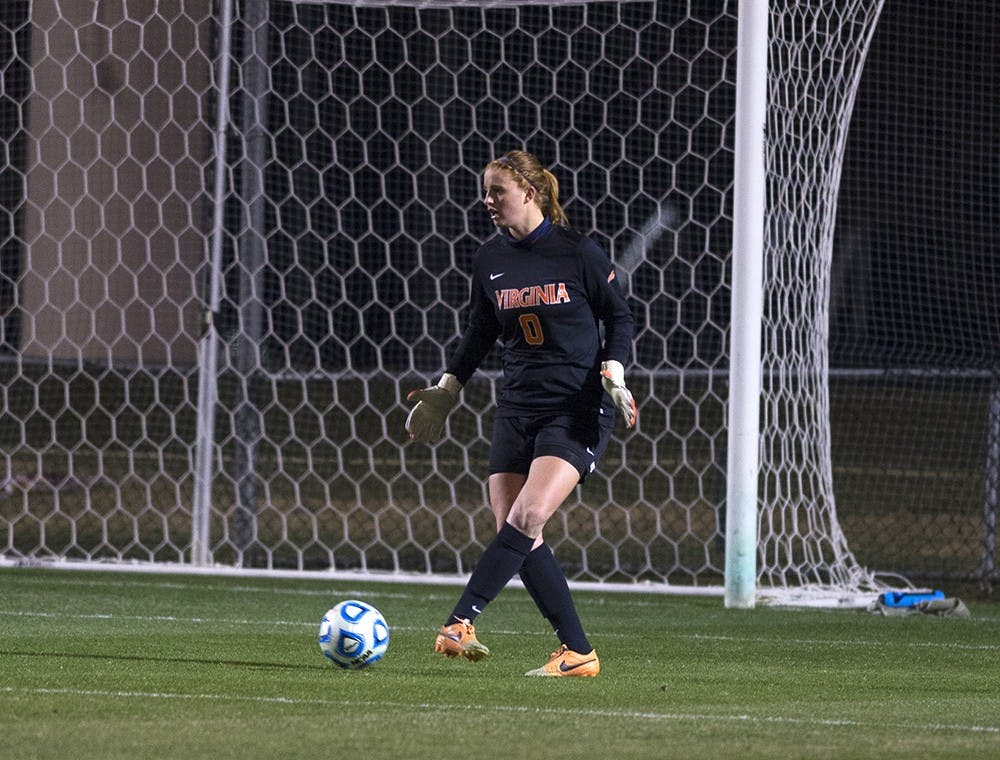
[319,599,389,670]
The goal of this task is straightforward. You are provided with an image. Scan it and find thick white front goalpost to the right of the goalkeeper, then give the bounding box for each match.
[725,0,768,608]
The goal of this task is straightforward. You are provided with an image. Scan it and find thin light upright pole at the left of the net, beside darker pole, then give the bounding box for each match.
[191,0,233,565]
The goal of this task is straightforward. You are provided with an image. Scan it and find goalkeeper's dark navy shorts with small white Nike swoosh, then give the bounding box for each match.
[490,413,614,483]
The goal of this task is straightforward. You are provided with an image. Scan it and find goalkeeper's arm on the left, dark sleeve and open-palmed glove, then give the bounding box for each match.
[406,270,500,443]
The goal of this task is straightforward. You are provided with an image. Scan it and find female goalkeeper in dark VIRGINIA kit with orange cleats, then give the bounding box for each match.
[406,150,636,676]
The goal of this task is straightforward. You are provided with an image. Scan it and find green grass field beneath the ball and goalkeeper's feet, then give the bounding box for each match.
[0,568,1000,760]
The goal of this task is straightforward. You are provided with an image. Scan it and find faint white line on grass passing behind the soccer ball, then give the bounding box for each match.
[0,609,1000,652]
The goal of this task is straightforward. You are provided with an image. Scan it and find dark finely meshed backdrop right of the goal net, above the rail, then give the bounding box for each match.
[831,1,1000,368]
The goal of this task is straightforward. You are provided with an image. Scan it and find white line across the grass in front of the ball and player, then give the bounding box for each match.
[0,686,1000,734]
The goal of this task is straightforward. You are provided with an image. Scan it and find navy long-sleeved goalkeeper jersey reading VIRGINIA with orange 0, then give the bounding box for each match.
[447,219,633,416]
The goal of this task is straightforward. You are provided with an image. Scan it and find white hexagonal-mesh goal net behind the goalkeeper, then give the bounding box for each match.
[0,0,992,590]
